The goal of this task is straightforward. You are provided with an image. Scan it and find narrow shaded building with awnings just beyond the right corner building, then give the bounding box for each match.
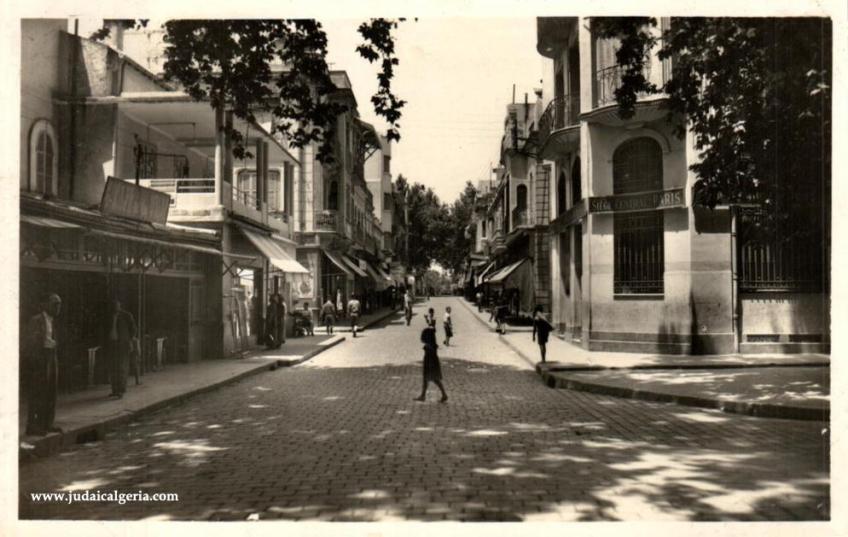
[478,100,551,315]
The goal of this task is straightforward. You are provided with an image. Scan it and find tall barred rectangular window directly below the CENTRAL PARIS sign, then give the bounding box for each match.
[613,211,665,294]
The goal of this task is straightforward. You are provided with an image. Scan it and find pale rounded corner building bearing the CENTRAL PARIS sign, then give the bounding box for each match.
[537,17,830,353]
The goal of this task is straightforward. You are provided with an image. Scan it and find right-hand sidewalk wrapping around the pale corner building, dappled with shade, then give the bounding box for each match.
[461,299,830,421]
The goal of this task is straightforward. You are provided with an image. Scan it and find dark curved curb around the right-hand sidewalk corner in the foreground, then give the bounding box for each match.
[536,367,830,421]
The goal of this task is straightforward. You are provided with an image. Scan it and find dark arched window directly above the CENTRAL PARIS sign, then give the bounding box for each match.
[612,137,663,194]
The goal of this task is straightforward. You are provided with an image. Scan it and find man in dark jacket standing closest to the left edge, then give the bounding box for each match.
[24,294,62,436]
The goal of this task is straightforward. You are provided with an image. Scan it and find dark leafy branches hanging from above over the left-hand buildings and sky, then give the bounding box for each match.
[92,18,405,162]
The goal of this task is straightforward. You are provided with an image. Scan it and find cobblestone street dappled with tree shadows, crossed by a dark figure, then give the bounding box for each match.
[20,298,829,521]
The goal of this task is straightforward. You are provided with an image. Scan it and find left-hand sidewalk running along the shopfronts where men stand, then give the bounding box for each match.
[19,309,394,461]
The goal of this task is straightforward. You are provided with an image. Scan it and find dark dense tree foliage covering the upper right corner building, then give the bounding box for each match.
[591,17,832,232]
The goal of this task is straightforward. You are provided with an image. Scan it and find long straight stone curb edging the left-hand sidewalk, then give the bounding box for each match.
[18,336,345,463]
